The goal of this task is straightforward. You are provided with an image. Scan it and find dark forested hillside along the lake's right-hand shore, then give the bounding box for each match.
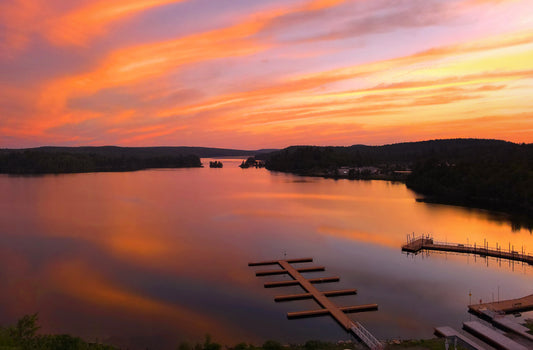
[265,139,533,224]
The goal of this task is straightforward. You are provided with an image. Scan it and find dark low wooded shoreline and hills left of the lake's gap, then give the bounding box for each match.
[0,146,274,175]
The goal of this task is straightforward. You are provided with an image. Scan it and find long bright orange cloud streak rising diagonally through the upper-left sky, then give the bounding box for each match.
[36,0,345,128]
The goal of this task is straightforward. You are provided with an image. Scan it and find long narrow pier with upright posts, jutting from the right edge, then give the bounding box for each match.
[402,236,533,265]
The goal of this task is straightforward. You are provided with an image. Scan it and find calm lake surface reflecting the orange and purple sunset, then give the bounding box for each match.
[0,160,533,348]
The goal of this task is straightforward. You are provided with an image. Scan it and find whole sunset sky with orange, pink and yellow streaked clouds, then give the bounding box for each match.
[0,0,533,149]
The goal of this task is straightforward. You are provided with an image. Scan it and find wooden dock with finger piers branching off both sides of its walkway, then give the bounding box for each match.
[248,258,383,350]
